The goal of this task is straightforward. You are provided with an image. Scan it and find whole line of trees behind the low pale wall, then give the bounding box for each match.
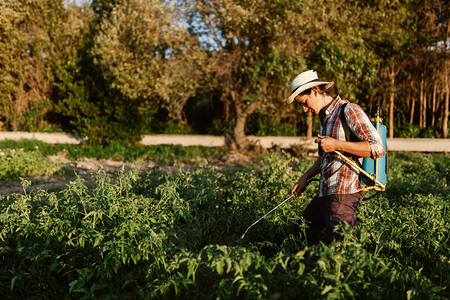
[0,0,450,148]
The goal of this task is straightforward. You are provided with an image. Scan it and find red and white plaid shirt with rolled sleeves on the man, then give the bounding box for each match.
[319,96,386,197]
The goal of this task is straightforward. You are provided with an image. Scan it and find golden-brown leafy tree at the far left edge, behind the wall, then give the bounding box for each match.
[0,0,95,131]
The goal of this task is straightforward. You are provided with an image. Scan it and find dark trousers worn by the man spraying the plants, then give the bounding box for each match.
[302,192,363,245]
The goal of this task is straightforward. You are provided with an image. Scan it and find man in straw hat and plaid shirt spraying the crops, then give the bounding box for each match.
[287,71,386,245]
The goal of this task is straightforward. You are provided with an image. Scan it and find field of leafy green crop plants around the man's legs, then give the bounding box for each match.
[0,144,450,299]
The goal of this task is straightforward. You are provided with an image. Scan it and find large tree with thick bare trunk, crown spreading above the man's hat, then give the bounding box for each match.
[189,0,386,149]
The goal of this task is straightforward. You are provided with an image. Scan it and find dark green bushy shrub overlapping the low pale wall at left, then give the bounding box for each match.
[53,0,158,146]
